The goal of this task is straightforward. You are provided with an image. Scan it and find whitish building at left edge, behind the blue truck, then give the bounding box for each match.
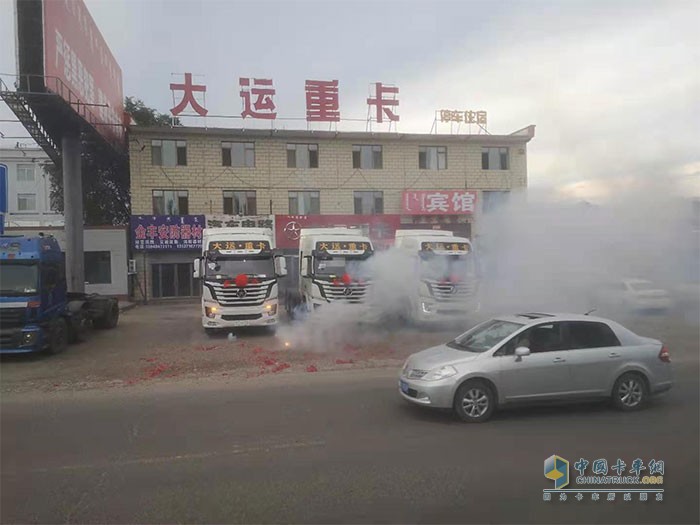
[0,143,63,227]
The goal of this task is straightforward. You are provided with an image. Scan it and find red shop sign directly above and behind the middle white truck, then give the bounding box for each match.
[275,215,401,249]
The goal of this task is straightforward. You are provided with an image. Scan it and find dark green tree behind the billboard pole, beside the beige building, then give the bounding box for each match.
[44,97,180,226]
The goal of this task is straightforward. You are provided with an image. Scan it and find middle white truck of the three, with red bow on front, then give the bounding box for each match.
[285,228,374,318]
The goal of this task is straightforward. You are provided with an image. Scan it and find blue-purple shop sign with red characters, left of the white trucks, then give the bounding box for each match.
[131,215,205,251]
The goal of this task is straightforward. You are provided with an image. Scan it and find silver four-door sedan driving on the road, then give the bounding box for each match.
[399,313,673,422]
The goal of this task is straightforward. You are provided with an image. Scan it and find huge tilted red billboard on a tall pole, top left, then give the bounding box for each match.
[43,0,124,145]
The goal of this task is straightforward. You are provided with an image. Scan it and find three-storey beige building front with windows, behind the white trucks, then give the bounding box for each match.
[129,126,535,297]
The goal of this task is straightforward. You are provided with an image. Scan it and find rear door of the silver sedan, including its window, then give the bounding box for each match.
[563,321,623,395]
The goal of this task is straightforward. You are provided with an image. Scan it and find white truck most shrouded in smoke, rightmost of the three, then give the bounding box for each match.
[394,230,480,324]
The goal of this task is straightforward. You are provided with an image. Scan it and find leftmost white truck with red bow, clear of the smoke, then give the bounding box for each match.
[194,228,287,335]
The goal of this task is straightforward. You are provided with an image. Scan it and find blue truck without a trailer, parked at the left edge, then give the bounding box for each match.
[0,234,119,354]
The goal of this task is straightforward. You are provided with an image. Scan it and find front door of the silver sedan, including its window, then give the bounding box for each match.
[496,322,572,401]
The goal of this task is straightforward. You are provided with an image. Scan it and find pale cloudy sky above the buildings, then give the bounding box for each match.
[0,0,700,201]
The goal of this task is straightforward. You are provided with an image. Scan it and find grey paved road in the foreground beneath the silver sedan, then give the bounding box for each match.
[1,360,700,523]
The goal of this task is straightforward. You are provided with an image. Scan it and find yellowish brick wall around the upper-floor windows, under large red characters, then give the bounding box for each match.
[130,132,527,214]
